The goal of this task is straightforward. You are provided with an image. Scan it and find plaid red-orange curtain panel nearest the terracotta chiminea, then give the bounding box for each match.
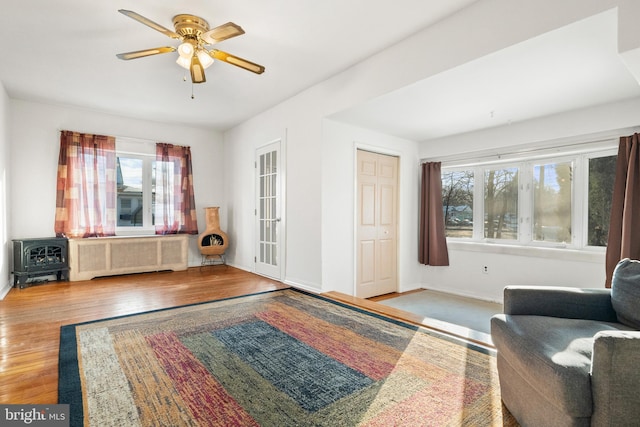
[155,143,198,234]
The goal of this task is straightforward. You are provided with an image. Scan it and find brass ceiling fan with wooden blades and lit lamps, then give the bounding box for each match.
[116,9,264,83]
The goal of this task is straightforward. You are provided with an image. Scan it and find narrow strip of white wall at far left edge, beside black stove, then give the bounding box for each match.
[0,82,12,299]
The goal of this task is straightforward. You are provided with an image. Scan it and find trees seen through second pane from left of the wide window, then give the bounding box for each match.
[484,168,518,240]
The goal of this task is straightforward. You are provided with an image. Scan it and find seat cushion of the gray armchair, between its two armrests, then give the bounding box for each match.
[491,314,630,417]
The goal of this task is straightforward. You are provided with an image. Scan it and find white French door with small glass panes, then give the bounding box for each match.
[255,141,283,280]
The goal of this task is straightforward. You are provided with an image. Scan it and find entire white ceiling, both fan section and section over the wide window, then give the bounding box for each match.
[0,0,640,141]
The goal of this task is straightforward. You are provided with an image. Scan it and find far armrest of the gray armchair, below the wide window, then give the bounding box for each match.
[504,286,618,322]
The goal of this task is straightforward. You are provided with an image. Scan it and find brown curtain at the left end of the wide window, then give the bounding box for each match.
[418,162,449,266]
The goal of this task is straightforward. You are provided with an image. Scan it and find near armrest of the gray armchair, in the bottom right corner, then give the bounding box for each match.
[591,331,640,426]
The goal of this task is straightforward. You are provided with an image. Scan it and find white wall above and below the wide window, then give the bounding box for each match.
[420,98,640,301]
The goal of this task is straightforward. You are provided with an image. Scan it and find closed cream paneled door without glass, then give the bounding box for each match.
[356,150,398,298]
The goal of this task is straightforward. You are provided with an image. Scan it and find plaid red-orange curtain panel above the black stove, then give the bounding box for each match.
[55,131,116,238]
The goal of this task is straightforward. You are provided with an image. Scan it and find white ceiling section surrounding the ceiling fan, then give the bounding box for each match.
[0,0,474,130]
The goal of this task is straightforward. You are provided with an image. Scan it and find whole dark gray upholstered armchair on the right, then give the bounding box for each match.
[491,259,640,427]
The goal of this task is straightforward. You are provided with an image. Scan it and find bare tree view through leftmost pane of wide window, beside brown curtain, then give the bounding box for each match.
[442,171,474,237]
